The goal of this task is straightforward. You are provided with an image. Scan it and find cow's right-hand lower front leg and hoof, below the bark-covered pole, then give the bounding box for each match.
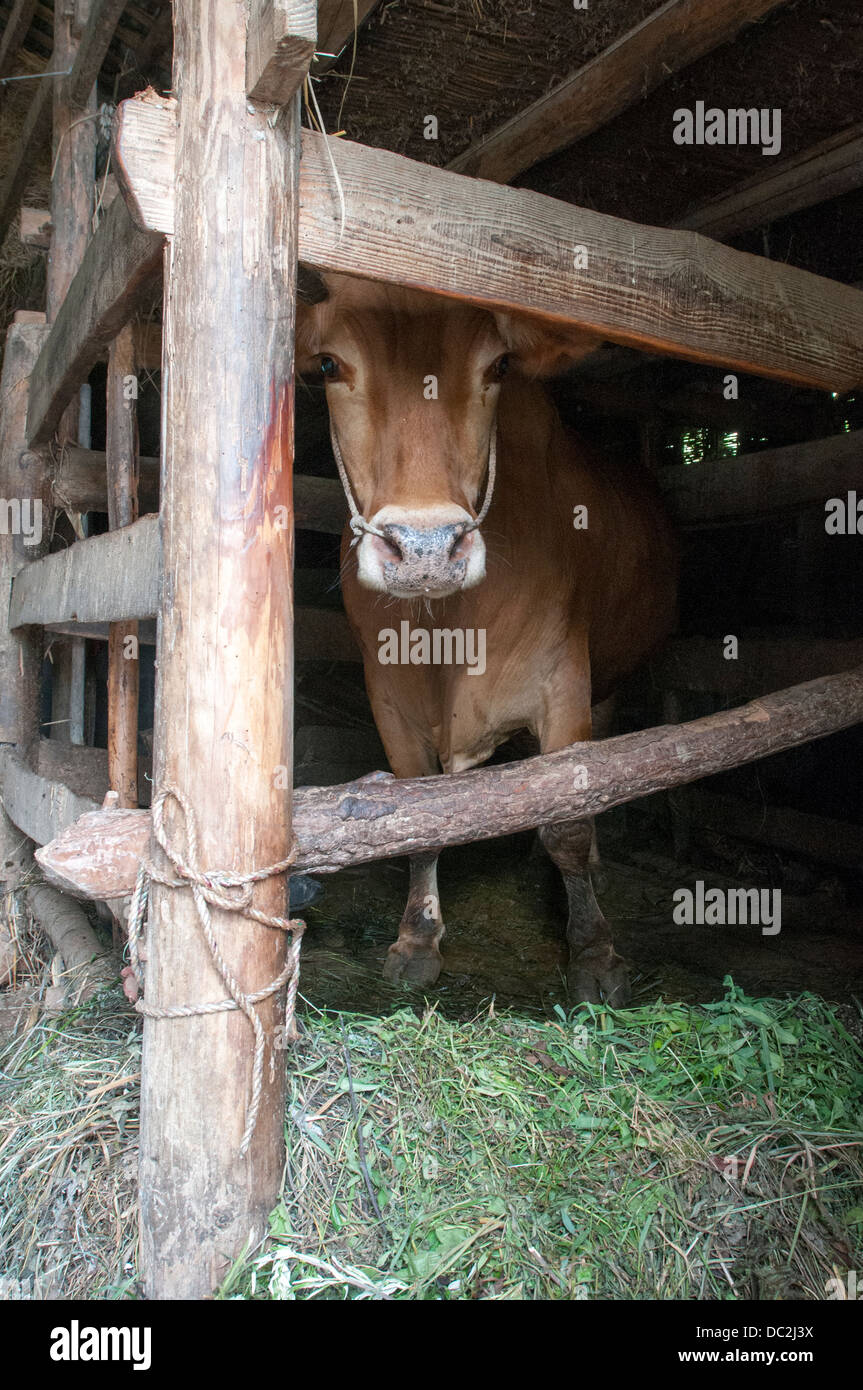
[539,820,630,1008]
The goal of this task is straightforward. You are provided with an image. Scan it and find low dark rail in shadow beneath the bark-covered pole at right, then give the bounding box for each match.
[684,787,863,872]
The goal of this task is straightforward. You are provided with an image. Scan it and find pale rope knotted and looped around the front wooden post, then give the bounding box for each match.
[128,787,306,1156]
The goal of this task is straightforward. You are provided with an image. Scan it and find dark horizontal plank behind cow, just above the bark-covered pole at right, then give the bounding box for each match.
[649,637,863,699]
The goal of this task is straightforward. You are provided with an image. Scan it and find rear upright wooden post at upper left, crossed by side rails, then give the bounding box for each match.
[46,0,96,744]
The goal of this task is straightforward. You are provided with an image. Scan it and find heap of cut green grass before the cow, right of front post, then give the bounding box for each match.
[230,981,863,1300]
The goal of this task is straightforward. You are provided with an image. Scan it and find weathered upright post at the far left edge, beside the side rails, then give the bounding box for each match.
[0,324,50,878]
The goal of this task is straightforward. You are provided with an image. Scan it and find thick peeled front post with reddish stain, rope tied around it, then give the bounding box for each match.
[140,0,299,1298]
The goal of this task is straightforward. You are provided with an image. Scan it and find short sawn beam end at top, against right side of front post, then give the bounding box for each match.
[246,0,317,106]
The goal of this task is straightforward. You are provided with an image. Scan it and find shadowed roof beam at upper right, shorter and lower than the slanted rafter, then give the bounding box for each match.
[674,122,863,240]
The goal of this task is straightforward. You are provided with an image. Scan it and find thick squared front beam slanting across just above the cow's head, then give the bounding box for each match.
[115,101,863,391]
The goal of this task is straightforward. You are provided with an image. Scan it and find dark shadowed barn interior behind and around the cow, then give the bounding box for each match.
[0,0,863,1017]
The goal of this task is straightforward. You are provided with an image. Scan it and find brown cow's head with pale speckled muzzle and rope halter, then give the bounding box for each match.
[296,275,596,599]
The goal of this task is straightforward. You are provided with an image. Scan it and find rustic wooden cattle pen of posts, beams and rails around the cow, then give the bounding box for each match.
[0,0,863,1300]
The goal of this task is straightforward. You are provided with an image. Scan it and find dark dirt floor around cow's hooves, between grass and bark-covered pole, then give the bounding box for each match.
[302,798,863,1019]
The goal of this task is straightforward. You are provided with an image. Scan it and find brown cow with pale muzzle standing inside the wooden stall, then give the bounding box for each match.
[297,275,675,1004]
